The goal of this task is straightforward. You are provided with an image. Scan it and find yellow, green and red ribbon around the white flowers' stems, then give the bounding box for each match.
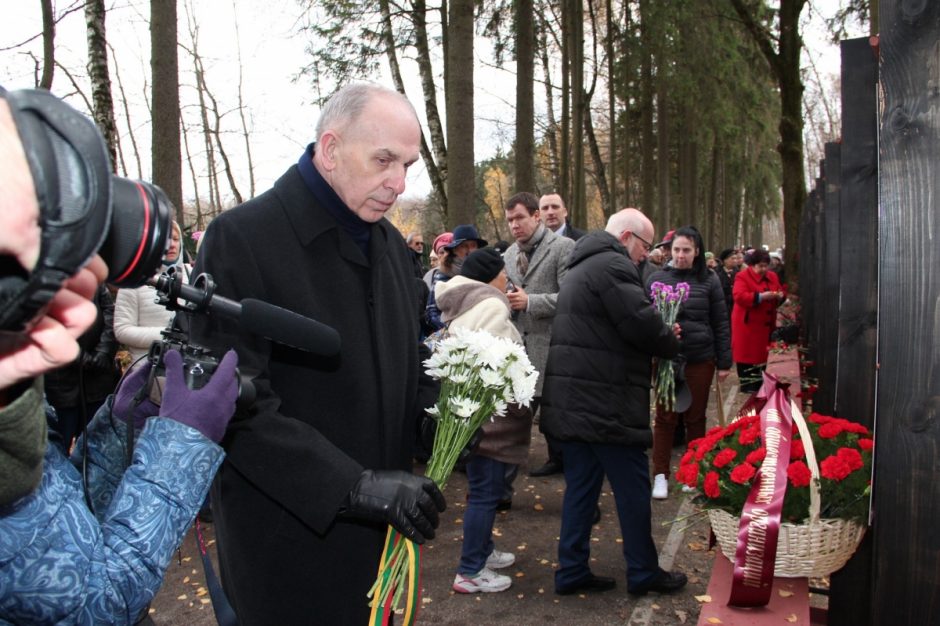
[369,526,421,626]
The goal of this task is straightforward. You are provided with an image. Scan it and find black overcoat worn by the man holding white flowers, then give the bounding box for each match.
[191,166,433,626]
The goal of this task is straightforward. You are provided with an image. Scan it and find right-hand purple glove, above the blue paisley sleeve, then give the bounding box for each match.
[160,350,238,443]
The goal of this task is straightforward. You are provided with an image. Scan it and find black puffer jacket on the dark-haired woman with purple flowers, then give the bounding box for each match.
[646,267,732,370]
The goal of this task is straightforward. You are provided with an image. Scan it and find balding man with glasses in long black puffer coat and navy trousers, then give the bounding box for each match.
[542,209,686,595]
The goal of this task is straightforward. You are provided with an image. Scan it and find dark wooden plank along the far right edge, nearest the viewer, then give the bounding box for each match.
[872,0,940,624]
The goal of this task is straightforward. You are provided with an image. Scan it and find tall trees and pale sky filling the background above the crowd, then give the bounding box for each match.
[0,0,877,287]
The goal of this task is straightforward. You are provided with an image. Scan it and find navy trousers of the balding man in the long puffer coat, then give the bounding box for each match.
[555,441,659,588]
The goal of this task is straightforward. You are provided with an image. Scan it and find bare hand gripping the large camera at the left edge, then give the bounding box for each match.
[0,256,108,389]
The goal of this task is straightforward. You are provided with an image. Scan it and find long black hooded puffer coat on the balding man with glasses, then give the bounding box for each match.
[541,231,679,447]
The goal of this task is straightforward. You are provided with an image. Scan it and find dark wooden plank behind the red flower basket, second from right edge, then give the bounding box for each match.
[829,37,878,626]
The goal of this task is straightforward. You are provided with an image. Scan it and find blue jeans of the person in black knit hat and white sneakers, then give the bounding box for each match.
[457,454,507,576]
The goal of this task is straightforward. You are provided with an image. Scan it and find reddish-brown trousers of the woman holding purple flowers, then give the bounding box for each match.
[653,361,715,476]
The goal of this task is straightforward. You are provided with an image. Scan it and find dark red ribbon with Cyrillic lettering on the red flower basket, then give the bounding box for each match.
[728,374,793,607]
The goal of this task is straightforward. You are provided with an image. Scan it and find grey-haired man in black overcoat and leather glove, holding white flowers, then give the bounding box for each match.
[191,84,444,626]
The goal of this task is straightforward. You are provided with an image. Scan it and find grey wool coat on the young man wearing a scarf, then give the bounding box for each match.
[503,228,574,396]
